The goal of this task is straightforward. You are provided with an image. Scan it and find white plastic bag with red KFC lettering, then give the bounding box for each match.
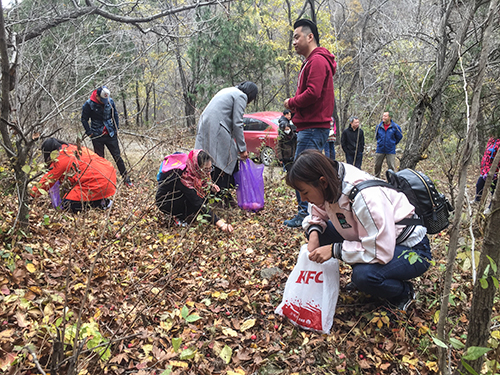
[275,244,340,334]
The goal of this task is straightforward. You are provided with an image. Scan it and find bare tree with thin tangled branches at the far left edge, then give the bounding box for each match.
[0,0,229,230]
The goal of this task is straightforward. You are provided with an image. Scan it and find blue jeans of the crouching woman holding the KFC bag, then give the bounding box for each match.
[319,221,432,301]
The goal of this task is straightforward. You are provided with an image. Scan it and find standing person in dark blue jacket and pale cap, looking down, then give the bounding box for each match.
[81,86,133,187]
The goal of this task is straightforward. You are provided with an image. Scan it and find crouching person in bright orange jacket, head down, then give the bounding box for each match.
[31,138,116,212]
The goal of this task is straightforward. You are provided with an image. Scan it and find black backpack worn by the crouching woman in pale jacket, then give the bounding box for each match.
[349,168,454,234]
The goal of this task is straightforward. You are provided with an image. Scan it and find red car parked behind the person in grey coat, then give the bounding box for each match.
[243,112,282,165]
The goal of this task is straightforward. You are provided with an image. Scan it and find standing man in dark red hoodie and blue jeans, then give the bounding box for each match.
[283,19,337,227]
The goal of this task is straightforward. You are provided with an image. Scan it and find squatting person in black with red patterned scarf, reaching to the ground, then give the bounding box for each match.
[156,150,233,233]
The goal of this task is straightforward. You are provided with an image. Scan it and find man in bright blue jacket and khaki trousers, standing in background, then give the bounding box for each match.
[375,112,403,178]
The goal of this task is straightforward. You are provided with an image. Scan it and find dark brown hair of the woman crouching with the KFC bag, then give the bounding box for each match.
[286,150,342,203]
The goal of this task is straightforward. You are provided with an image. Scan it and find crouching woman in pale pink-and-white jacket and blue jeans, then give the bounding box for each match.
[286,150,432,310]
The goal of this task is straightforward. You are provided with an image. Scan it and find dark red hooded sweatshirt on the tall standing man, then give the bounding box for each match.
[288,47,337,131]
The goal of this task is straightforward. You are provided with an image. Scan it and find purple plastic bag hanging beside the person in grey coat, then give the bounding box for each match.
[234,159,264,211]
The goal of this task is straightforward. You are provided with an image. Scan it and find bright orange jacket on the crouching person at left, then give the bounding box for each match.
[31,145,116,202]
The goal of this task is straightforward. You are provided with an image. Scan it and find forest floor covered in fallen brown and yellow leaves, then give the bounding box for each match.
[0,139,500,375]
